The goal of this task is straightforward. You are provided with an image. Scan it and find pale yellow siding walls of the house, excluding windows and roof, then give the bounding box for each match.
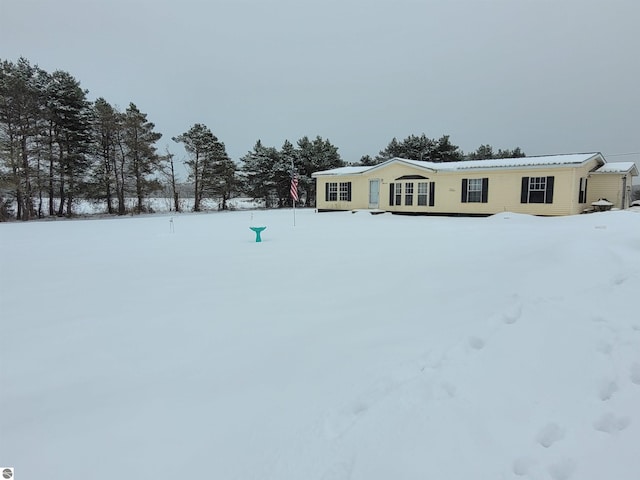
[317,157,631,216]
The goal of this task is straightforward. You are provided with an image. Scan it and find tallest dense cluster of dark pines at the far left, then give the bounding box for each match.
[0,58,168,220]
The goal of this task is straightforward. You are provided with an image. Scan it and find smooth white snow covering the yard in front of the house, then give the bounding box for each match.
[0,209,640,480]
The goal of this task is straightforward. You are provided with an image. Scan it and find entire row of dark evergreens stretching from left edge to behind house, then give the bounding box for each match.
[0,58,524,220]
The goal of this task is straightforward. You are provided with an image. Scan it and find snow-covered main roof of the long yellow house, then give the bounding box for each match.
[313,153,604,176]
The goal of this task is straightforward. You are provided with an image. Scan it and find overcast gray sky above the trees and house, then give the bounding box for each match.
[0,0,640,174]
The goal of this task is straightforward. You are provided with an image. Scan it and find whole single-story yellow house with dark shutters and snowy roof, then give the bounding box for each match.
[312,153,638,215]
